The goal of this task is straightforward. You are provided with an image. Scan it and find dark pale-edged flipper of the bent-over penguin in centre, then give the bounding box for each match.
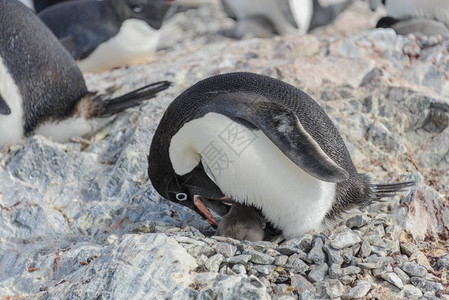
[237,102,349,182]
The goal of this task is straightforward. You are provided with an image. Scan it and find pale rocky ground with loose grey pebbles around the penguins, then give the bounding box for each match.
[0,2,449,299]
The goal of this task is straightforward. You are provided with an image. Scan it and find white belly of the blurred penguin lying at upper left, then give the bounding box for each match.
[78,19,160,72]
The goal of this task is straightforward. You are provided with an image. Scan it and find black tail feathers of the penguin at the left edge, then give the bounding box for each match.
[92,81,171,118]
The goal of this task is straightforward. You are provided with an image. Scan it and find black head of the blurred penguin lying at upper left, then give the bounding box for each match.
[113,0,174,29]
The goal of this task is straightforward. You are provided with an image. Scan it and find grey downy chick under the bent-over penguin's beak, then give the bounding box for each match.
[216,203,266,242]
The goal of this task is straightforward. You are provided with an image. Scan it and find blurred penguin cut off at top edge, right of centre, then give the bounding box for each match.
[222,0,353,38]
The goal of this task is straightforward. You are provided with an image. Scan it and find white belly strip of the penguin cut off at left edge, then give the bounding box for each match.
[0,57,24,149]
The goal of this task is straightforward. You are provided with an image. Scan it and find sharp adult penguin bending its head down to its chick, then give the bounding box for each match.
[148,73,412,238]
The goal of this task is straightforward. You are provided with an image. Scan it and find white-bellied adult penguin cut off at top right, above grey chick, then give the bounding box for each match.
[370,0,449,27]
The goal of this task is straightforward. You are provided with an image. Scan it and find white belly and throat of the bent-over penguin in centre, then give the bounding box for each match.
[169,113,335,238]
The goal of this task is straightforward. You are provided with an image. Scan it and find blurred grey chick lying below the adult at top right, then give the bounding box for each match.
[376,17,449,36]
